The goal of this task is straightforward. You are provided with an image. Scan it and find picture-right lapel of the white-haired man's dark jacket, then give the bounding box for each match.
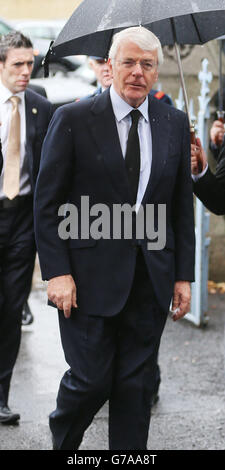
[142,97,170,204]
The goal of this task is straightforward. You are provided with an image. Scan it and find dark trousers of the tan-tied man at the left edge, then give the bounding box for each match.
[0,196,36,405]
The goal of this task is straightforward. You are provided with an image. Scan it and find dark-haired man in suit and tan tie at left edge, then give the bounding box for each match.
[0,32,52,424]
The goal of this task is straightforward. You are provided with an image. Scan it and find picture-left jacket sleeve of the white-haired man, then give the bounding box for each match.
[34,106,74,280]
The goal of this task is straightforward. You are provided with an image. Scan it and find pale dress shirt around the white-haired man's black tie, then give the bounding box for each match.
[110,85,152,212]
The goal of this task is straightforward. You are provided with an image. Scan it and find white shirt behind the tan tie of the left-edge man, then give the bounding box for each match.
[0,80,31,199]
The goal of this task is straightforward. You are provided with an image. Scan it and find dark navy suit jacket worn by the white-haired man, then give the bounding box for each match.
[35,90,195,316]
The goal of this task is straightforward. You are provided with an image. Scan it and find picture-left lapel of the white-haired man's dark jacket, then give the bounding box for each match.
[89,89,131,204]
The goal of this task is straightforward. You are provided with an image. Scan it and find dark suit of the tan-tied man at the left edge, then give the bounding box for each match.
[0,89,51,404]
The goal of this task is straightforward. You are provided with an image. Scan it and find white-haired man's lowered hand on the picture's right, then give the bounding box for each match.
[172,281,191,321]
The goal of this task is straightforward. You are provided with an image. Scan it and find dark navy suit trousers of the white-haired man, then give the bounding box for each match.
[50,249,167,450]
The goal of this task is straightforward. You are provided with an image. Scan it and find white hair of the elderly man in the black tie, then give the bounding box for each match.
[109,26,163,65]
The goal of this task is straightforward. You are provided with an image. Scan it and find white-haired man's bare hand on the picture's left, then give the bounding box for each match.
[47,274,77,318]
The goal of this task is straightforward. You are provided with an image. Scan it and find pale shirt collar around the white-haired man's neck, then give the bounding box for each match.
[110,85,149,122]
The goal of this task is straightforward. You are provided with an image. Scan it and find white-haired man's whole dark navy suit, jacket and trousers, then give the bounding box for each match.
[35,86,194,449]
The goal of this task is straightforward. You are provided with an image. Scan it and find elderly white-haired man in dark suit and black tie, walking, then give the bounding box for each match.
[35,27,195,450]
